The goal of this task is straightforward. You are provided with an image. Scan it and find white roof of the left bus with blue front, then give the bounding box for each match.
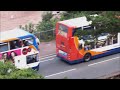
[0,28,32,42]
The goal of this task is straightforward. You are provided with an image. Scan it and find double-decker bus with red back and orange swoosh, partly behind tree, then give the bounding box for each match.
[56,17,120,64]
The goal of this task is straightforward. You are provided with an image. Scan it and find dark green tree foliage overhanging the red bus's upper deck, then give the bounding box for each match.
[70,11,120,38]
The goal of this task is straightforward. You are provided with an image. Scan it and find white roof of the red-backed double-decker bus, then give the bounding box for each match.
[58,16,92,28]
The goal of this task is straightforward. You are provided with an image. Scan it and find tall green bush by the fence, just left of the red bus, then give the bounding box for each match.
[36,12,58,42]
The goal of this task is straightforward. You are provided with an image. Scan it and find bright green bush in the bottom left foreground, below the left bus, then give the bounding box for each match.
[0,62,44,79]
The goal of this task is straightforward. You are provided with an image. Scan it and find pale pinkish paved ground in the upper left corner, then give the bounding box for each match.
[0,11,44,31]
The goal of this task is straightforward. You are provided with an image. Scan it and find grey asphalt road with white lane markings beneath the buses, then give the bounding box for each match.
[38,53,120,79]
